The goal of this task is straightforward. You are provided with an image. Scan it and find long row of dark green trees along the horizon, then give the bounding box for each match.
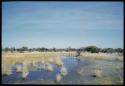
[2,46,124,53]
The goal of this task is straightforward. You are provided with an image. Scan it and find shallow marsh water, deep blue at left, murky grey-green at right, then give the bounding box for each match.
[2,57,123,84]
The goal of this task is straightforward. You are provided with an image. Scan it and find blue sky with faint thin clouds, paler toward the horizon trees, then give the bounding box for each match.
[2,1,124,48]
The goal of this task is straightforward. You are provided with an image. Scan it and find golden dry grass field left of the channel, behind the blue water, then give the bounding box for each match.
[2,52,76,75]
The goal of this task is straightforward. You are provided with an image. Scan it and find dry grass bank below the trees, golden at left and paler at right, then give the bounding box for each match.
[2,52,123,75]
